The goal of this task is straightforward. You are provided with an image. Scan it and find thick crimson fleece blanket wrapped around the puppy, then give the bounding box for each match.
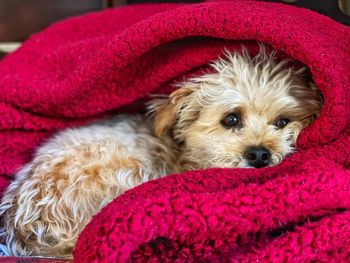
[0,0,350,262]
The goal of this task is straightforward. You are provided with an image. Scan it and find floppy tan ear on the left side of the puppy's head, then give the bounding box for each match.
[152,87,193,137]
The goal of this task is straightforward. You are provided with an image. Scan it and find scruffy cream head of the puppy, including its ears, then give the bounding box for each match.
[153,48,322,170]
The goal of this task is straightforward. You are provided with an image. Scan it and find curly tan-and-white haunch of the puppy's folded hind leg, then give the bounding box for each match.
[0,139,144,257]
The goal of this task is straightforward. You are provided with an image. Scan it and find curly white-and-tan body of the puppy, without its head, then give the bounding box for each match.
[0,114,177,257]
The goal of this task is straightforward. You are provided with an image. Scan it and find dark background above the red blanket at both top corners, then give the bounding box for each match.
[0,0,350,57]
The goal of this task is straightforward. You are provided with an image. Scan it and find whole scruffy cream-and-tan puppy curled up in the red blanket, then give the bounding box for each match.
[0,47,322,257]
